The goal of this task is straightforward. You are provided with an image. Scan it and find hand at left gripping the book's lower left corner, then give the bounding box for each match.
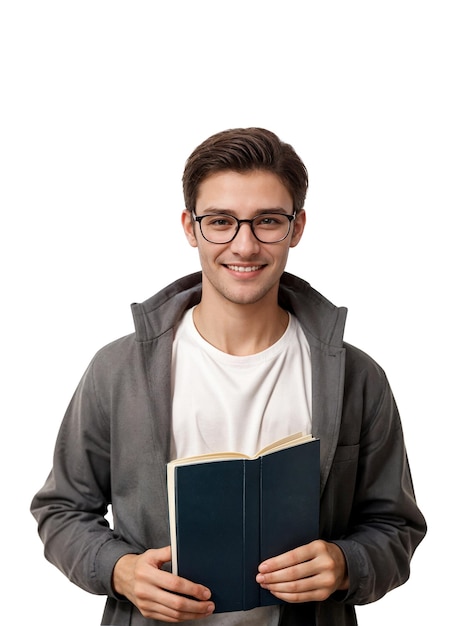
[112,546,215,622]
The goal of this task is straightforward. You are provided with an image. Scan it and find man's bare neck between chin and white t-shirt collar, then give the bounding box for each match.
[193,301,289,356]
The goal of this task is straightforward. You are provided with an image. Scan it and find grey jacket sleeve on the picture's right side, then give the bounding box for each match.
[331,351,426,604]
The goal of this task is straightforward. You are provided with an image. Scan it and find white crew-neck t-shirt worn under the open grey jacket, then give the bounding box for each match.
[171,309,311,626]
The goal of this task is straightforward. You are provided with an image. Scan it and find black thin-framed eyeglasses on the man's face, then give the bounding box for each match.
[192,211,296,243]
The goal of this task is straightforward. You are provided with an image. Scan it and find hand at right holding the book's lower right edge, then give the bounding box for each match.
[256,540,349,602]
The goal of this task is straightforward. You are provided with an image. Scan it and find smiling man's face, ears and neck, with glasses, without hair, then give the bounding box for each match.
[182,170,306,355]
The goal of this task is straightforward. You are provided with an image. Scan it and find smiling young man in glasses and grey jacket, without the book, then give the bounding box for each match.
[32,128,426,626]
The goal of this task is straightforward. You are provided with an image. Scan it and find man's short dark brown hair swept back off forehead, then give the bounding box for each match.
[182,128,308,212]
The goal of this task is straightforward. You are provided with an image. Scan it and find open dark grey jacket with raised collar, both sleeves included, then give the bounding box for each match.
[31,273,426,626]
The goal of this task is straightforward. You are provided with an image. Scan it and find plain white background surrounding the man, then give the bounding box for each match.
[0,0,476,626]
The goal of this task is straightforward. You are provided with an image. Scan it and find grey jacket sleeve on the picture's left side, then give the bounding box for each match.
[31,352,138,596]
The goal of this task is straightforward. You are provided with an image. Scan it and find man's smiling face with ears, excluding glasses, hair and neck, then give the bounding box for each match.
[182,171,306,304]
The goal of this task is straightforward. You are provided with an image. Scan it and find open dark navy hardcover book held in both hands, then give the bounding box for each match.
[167,433,320,613]
